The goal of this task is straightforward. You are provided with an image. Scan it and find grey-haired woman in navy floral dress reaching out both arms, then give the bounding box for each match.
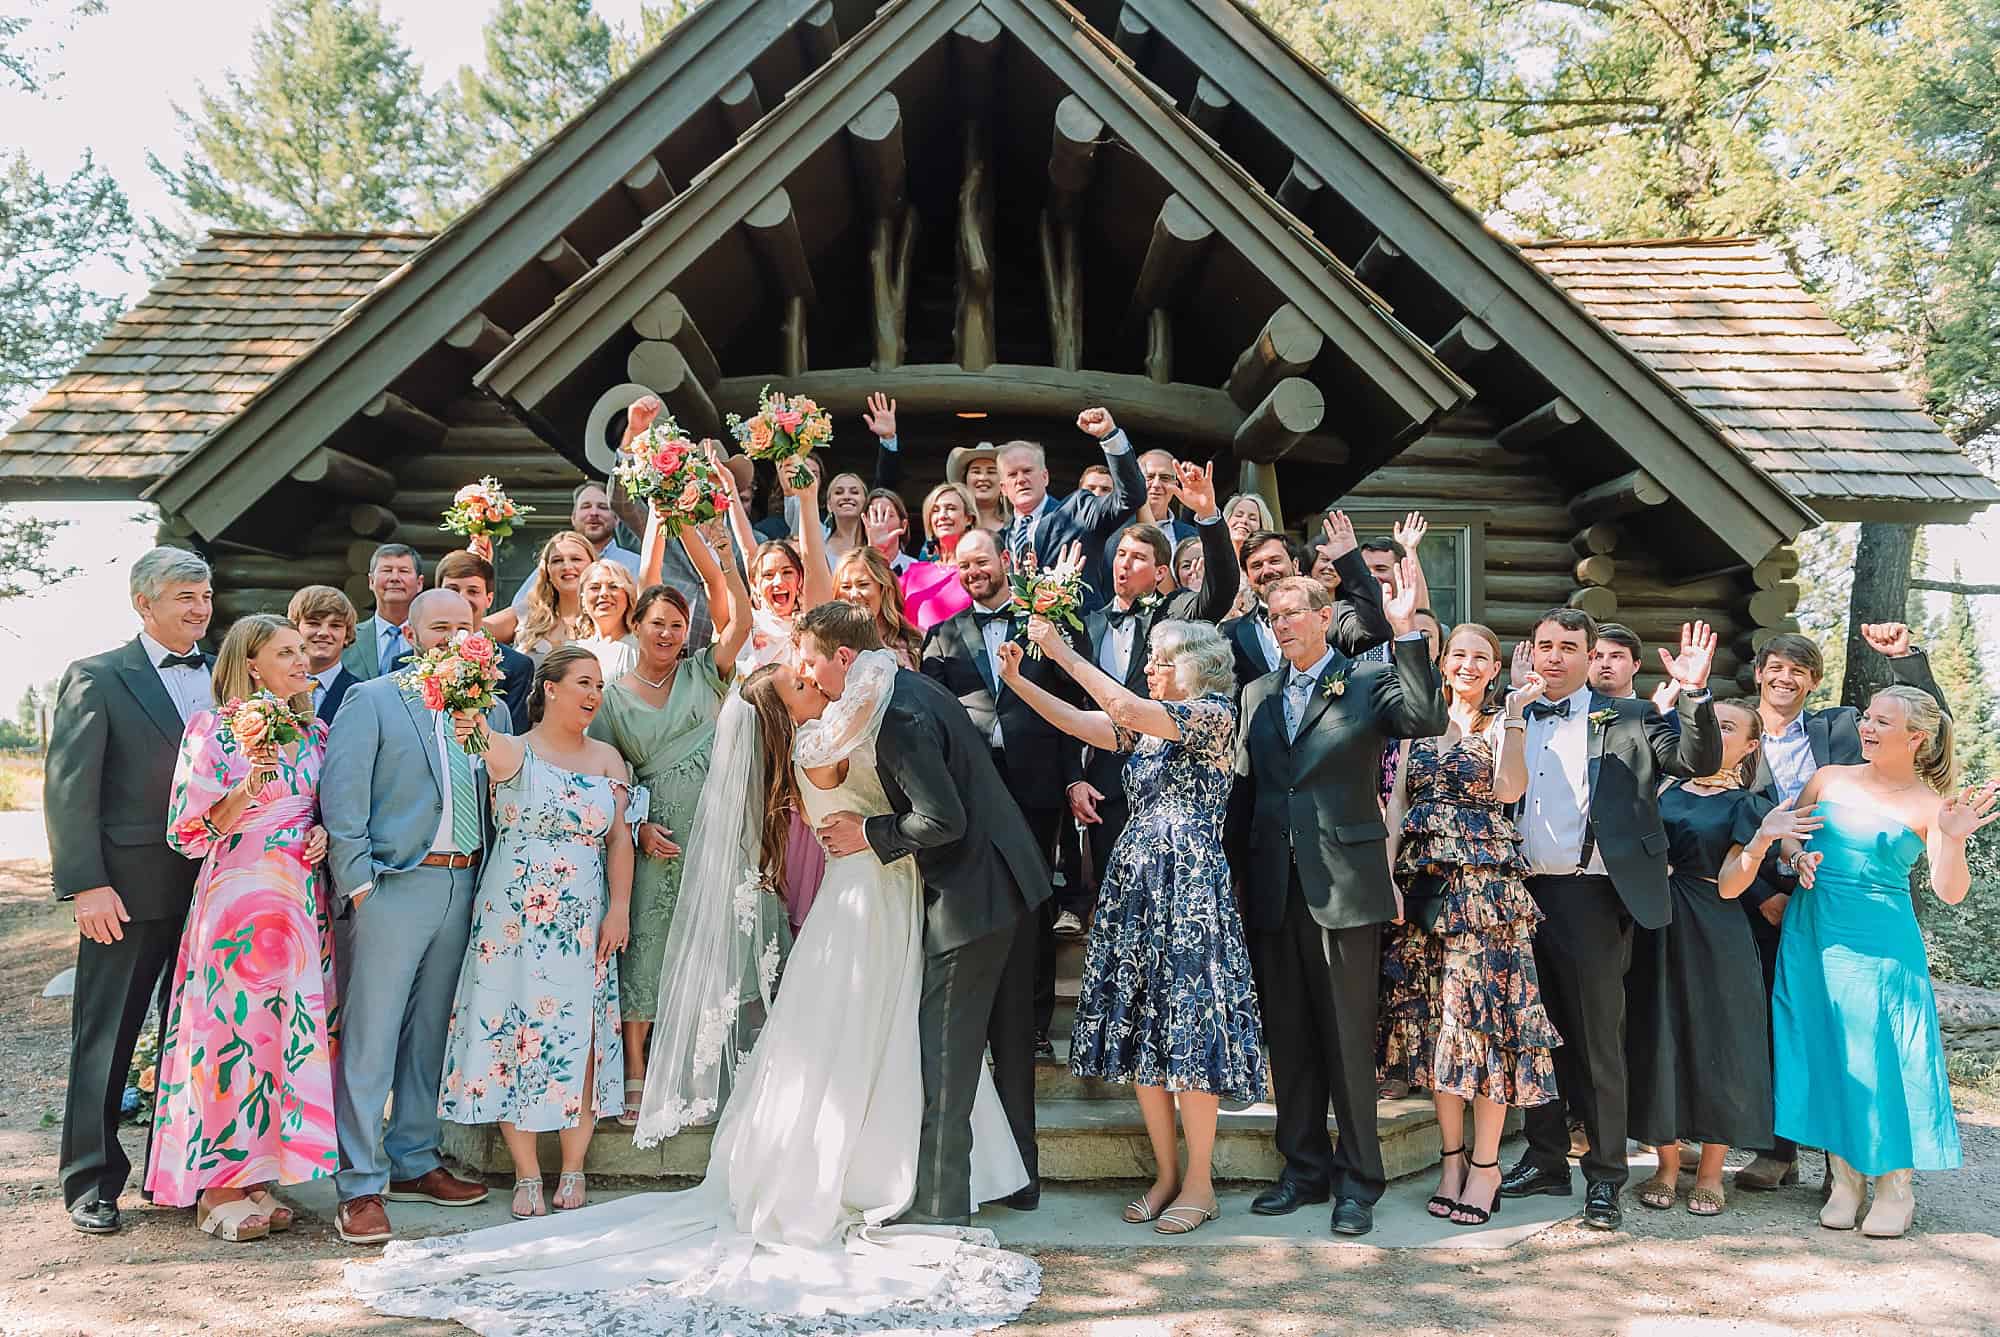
[1000,616,1266,1235]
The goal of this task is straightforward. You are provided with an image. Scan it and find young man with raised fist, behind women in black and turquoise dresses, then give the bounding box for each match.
[1736,622,1950,1189]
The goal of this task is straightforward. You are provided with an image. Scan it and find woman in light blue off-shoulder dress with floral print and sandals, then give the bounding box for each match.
[440,646,648,1217]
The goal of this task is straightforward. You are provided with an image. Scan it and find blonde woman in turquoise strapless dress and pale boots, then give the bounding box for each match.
[1772,687,2000,1237]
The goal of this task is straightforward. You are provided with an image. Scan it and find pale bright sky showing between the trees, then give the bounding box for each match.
[0,0,2000,715]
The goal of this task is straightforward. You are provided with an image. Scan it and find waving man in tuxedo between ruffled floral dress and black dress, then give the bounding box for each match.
[1500,608,1722,1231]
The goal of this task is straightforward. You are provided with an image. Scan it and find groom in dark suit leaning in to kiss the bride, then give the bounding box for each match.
[798,602,1050,1225]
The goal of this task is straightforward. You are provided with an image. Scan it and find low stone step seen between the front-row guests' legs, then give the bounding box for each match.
[444,1079,1472,1181]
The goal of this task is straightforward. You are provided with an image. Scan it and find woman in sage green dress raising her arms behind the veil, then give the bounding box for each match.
[590,520,750,1125]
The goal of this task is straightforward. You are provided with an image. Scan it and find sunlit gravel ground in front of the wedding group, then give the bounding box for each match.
[0,861,2000,1337]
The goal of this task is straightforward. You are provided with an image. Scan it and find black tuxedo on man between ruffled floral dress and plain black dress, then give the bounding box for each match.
[1524,691,1722,1185]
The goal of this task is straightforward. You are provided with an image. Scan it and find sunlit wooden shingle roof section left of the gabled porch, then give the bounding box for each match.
[0,232,430,494]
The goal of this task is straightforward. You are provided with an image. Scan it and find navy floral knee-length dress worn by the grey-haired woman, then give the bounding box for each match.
[1070,695,1266,1101]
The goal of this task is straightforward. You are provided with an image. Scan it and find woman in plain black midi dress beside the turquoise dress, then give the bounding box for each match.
[1626,701,1818,1217]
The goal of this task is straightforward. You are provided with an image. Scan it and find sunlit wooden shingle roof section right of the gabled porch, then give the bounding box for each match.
[1522,238,2000,518]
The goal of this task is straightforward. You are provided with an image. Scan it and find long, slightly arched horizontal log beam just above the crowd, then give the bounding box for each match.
[716,362,1348,464]
